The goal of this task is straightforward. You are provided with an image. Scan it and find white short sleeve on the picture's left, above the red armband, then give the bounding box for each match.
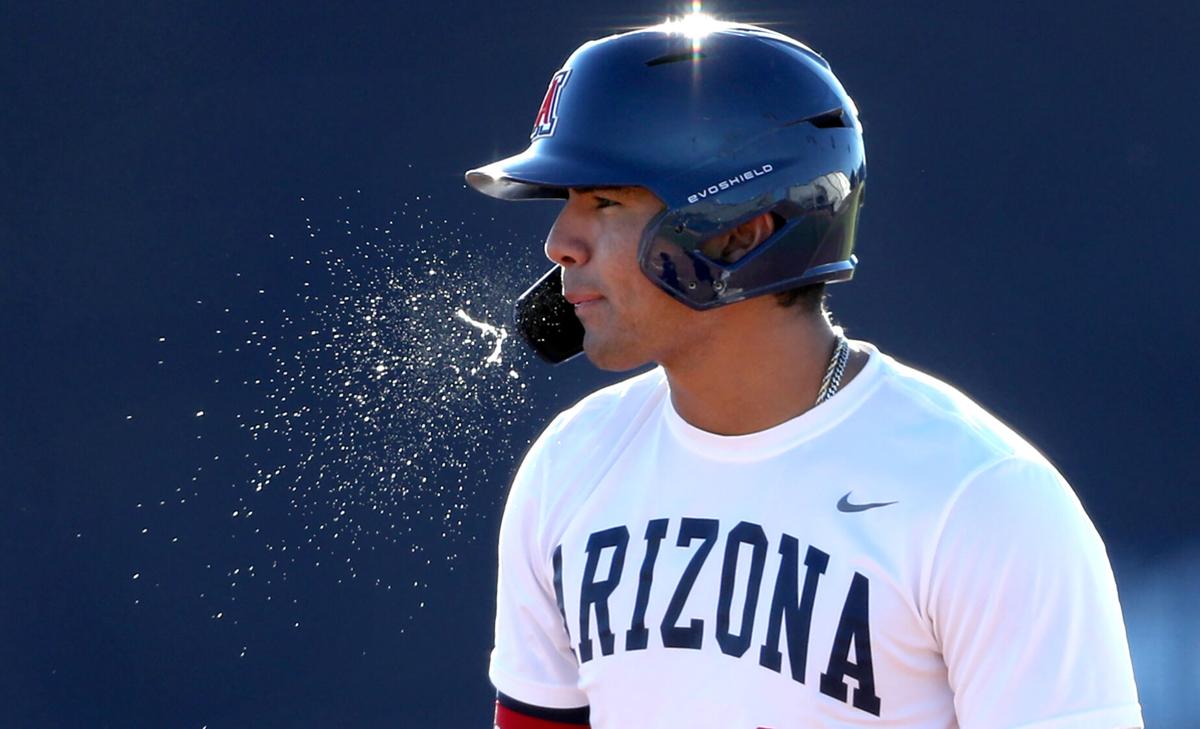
[488,426,588,709]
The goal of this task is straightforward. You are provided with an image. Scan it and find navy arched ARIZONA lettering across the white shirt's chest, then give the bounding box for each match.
[553,517,881,716]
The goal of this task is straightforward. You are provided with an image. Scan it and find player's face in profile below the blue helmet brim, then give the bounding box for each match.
[546,187,700,369]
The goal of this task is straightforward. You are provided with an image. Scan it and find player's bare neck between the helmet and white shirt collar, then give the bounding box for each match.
[661,300,865,435]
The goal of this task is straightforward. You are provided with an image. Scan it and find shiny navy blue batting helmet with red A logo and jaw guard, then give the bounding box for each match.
[467,23,866,362]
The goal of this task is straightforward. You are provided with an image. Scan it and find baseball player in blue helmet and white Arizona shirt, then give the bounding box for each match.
[467,18,1141,729]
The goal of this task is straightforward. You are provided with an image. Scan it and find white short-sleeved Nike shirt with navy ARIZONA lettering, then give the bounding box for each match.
[490,342,1141,729]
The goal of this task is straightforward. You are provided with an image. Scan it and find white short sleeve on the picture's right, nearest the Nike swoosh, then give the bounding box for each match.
[928,457,1142,729]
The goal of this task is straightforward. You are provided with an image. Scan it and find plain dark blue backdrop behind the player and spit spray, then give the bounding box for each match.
[0,0,1200,729]
